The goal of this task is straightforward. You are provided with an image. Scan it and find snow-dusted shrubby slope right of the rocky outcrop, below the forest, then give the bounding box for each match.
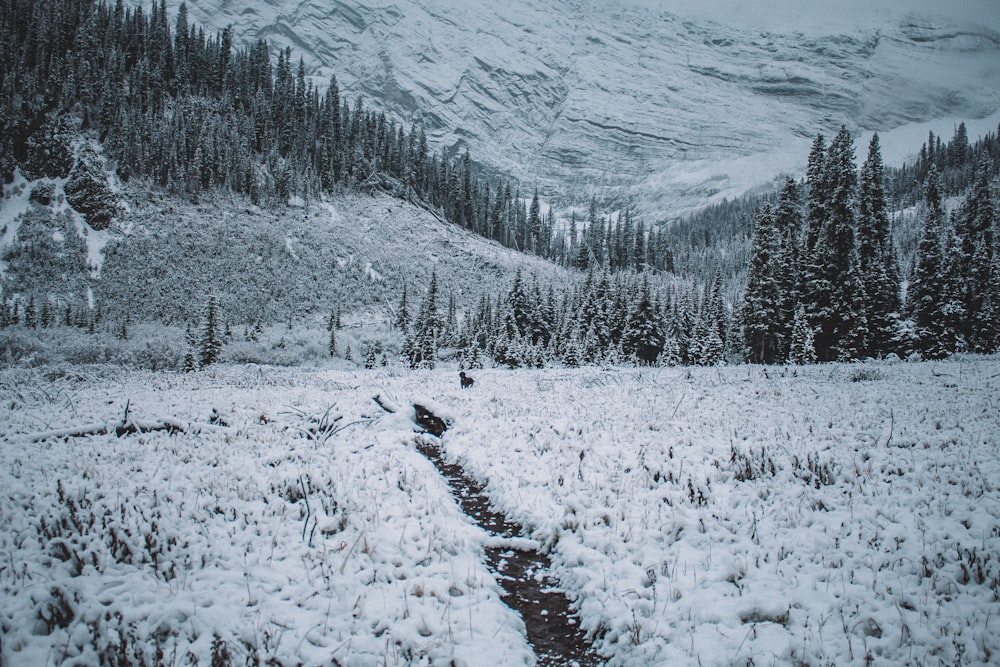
[100,189,563,322]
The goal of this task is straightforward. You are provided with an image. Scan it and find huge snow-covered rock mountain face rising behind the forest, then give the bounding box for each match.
[168,0,1000,217]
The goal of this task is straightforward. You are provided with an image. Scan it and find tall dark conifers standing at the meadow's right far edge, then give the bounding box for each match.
[741,127,1000,363]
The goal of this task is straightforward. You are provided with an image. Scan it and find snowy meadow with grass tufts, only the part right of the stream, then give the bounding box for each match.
[445,358,1000,665]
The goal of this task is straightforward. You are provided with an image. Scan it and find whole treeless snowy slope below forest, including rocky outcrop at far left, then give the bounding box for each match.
[0,179,566,324]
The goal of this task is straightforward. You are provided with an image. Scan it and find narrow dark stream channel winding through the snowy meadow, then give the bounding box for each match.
[414,405,604,667]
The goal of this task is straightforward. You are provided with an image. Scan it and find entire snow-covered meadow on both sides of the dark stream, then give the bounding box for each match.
[0,357,1000,666]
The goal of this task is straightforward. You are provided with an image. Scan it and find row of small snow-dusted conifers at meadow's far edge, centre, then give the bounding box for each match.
[393,269,732,368]
